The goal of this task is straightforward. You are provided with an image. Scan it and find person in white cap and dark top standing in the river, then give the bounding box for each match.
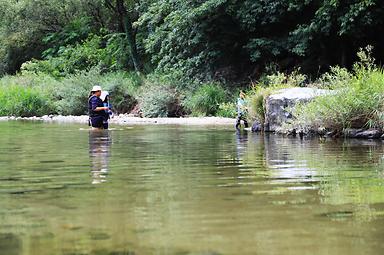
[88,86,109,129]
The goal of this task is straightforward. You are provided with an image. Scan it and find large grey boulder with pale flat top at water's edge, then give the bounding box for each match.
[264,87,333,132]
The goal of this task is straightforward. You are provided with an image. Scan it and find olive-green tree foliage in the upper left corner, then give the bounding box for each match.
[0,0,95,74]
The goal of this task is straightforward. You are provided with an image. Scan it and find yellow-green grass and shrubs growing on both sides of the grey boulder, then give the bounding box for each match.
[248,46,384,131]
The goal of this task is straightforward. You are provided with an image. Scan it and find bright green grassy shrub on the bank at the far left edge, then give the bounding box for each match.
[0,85,54,117]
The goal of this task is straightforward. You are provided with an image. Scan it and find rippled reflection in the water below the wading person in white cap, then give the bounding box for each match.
[89,130,111,184]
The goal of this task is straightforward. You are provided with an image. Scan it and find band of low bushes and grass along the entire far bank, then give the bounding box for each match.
[0,47,384,130]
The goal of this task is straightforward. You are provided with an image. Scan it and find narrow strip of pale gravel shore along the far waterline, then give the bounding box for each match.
[0,114,236,126]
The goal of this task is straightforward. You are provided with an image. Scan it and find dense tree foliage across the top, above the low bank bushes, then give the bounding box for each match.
[0,0,384,80]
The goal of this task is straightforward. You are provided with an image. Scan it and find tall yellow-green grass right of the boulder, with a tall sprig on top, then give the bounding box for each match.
[292,48,384,130]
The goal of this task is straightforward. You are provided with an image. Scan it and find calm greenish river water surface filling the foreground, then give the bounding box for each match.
[0,122,384,255]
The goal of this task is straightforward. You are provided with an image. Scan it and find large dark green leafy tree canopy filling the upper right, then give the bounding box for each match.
[138,0,384,79]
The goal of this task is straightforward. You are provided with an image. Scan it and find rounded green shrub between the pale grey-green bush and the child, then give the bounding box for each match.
[183,83,227,116]
